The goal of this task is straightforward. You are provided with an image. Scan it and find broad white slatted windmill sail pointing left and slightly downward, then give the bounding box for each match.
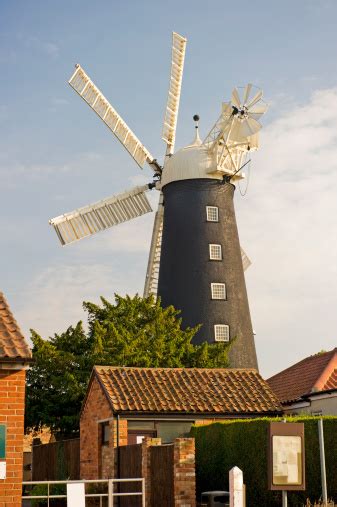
[49,185,152,245]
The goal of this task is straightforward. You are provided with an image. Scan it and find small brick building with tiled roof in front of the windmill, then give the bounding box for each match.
[80,366,282,479]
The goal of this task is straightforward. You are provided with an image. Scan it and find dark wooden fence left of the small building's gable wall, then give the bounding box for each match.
[32,438,80,481]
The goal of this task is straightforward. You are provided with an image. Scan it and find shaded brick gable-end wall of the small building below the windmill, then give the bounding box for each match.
[79,377,113,480]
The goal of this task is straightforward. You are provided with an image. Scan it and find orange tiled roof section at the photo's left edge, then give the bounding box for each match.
[0,292,32,362]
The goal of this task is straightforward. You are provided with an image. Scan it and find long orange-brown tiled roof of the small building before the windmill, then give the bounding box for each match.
[94,366,281,415]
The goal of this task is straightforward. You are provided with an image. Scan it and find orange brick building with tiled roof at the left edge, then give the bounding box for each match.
[0,292,31,507]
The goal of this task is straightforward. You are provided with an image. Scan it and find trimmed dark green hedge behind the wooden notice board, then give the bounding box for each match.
[190,416,337,507]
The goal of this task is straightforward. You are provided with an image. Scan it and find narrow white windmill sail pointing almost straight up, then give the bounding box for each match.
[162,32,187,153]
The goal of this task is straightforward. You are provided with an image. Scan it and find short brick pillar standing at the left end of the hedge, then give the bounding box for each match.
[173,438,196,507]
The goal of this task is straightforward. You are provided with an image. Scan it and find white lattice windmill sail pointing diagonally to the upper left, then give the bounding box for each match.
[69,64,156,168]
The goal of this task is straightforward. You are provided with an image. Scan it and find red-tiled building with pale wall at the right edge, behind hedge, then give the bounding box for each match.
[267,348,337,415]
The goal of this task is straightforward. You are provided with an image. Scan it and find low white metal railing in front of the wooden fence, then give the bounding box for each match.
[22,478,145,507]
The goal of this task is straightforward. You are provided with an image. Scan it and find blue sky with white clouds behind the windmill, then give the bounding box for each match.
[0,0,337,378]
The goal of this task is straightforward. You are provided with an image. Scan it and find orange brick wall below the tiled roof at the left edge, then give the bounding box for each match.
[0,370,26,507]
